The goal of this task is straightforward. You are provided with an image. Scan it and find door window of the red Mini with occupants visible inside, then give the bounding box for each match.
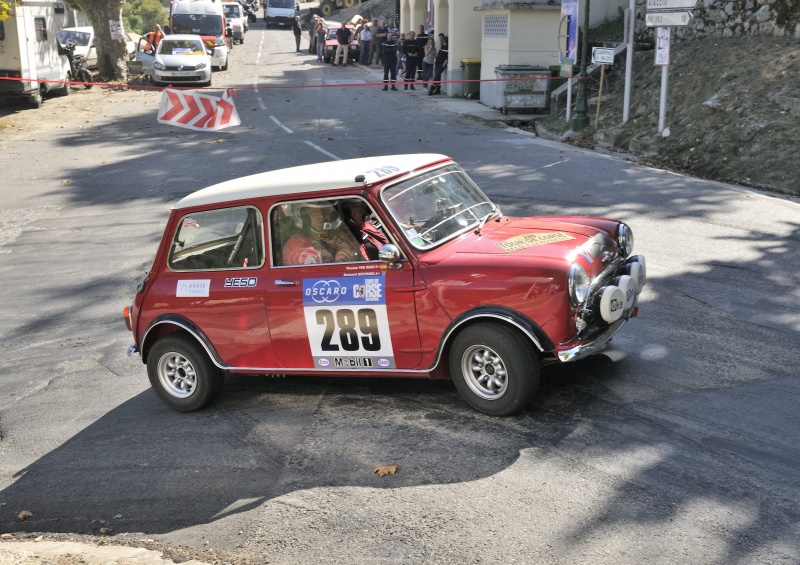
[270,200,369,266]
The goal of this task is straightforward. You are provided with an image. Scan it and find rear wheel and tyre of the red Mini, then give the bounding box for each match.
[147,334,223,412]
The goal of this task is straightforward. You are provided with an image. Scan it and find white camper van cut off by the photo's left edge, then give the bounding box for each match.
[0,0,70,108]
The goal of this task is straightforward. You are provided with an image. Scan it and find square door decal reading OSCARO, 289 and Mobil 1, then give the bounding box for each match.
[303,276,395,370]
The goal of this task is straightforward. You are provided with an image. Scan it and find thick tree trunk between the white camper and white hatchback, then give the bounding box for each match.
[75,0,128,81]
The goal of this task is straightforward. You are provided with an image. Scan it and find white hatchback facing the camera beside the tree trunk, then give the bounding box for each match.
[136,35,211,86]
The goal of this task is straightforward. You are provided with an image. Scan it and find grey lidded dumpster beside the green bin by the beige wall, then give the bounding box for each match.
[493,65,550,114]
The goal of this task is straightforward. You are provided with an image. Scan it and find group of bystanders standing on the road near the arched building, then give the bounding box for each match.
[302,15,448,96]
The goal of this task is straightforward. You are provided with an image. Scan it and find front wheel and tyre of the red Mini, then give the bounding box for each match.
[449,323,539,416]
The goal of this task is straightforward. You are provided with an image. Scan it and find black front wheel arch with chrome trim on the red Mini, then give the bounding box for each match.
[431,306,555,373]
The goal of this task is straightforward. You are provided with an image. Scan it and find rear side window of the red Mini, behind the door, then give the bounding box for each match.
[168,206,264,271]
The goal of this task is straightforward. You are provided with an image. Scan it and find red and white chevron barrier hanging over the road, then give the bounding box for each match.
[158,88,242,131]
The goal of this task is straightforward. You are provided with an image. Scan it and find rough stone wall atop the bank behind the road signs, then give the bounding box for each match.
[636,0,800,39]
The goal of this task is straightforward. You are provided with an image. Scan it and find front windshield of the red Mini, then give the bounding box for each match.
[381,165,500,249]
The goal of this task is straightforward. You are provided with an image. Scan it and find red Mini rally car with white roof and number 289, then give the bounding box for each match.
[123,154,646,416]
